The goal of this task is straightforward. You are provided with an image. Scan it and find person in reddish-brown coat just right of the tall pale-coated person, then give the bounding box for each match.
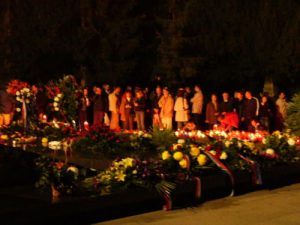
[205,94,219,129]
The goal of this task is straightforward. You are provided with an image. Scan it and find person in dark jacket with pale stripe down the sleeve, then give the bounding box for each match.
[242,91,259,131]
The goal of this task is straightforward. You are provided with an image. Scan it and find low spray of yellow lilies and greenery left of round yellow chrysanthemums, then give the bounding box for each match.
[83,157,175,195]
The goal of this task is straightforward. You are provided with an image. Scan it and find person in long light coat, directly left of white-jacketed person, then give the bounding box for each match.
[158,87,174,130]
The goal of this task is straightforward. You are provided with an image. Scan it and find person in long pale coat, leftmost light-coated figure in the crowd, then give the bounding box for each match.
[108,87,121,131]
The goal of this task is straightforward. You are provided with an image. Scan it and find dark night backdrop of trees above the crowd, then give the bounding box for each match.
[0,0,300,94]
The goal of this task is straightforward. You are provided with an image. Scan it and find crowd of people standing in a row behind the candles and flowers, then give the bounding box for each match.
[0,81,288,132]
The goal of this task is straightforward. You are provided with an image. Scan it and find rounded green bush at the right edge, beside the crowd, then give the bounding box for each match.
[287,93,300,136]
